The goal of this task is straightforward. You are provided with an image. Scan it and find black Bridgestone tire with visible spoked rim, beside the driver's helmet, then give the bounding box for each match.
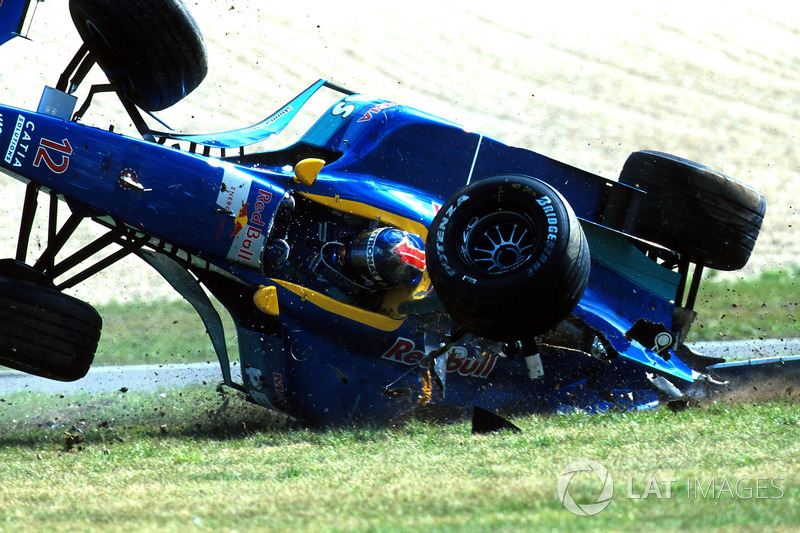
[426,175,590,341]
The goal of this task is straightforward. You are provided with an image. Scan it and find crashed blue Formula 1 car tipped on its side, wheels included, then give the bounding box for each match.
[0,0,780,424]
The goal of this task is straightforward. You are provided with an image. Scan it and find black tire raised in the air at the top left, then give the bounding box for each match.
[69,0,208,111]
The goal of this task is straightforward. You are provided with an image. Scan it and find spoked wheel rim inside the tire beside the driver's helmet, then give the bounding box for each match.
[459,211,538,275]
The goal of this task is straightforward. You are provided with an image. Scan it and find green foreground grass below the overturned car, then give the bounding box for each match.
[0,388,800,531]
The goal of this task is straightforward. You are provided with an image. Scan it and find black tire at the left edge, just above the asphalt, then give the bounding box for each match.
[0,275,102,381]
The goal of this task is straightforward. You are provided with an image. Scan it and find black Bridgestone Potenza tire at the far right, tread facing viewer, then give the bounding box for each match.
[619,151,767,270]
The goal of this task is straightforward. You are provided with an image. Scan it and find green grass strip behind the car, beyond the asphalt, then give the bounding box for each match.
[84,271,800,365]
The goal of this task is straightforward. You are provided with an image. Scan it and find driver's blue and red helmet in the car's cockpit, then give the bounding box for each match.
[345,227,425,287]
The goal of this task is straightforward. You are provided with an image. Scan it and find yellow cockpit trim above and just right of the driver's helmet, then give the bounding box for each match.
[300,193,431,318]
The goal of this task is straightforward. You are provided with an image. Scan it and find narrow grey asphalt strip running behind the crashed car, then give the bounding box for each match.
[0,339,800,398]
